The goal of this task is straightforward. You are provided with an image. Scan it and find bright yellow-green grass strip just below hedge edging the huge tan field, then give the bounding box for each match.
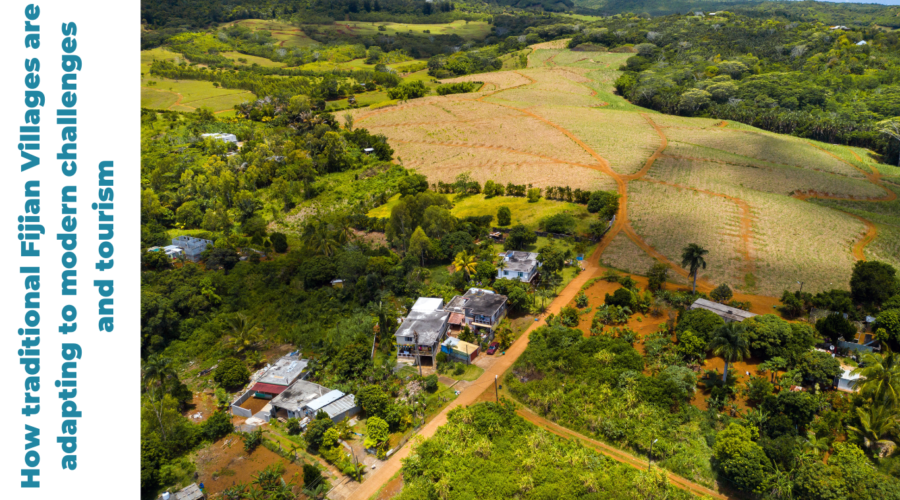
[368,194,595,233]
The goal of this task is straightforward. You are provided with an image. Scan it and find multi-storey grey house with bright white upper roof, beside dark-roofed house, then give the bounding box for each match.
[394,297,450,364]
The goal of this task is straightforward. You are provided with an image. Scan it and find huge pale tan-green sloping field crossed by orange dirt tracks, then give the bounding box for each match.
[354,42,900,296]
